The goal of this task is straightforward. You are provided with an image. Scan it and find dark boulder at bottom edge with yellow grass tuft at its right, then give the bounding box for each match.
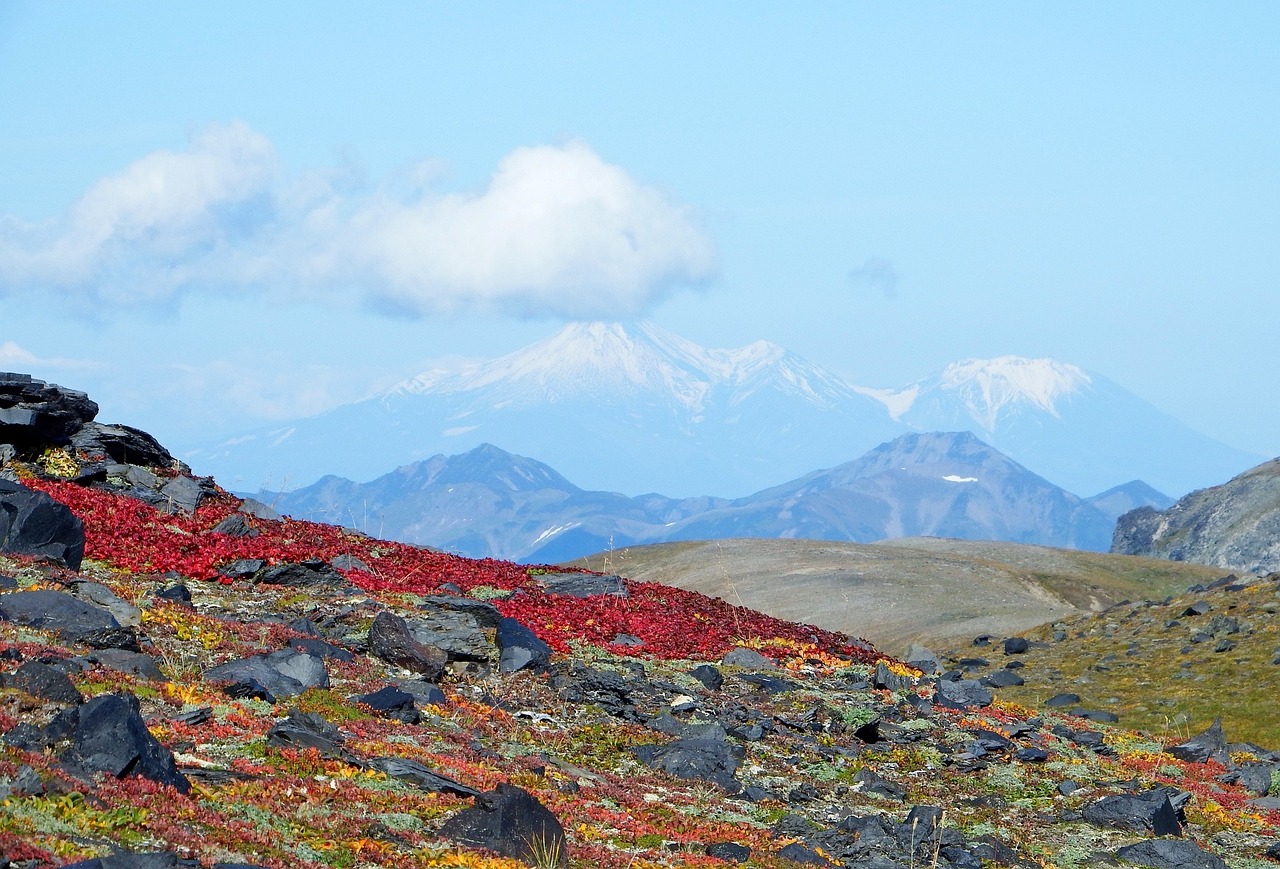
[440,785,568,868]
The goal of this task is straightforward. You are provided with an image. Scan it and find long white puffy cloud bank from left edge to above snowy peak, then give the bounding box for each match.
[0,123,716,317]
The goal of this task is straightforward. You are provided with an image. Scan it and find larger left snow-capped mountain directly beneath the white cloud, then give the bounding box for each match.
[192,323,901,495]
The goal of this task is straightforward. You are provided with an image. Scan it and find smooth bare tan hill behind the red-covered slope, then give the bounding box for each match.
[567,538,1221,654]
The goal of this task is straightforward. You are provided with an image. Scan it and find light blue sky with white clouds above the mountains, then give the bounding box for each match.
[0,0,1280,463]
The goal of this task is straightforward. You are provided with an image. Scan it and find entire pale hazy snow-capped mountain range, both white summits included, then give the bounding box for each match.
[183,323,1261,497]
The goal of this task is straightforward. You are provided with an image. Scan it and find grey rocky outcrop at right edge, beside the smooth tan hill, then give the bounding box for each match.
[1111,459,1280,575]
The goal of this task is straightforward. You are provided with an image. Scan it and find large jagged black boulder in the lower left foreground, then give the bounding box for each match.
[64,694,191,793]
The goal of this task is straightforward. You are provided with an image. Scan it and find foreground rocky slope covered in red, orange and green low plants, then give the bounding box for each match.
[0,373,1280,869]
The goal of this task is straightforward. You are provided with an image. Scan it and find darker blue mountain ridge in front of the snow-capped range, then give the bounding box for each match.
[260,433,1126,563]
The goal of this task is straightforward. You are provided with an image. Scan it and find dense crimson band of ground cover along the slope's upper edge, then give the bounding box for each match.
[37,480,881,662]
